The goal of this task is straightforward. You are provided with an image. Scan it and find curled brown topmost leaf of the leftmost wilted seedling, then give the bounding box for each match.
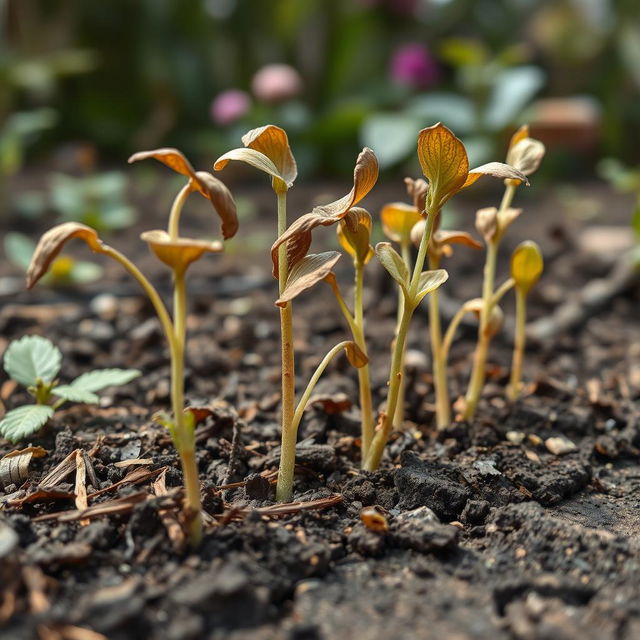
[129,147,238,240]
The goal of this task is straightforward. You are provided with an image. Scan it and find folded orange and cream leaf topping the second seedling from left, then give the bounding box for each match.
[213,124,298,192]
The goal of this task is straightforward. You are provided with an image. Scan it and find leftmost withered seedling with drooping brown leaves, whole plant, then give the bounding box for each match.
[27,148,238,546]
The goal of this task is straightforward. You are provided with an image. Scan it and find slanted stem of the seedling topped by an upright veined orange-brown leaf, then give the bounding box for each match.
[362,211,438,471]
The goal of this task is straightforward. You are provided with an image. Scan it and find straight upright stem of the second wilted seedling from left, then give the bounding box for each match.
[276,191,297,501]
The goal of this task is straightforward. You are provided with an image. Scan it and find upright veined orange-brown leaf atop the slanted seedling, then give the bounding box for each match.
[418,122,469,209]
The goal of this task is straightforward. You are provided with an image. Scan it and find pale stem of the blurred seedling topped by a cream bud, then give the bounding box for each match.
[463,184,516,420]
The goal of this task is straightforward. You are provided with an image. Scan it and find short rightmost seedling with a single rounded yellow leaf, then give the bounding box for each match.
[507,241,544,401]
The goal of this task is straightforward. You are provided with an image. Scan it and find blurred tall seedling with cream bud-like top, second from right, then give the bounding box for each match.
[462,125,545,420]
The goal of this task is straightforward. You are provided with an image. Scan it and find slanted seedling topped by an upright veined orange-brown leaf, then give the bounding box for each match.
[364,123,526,471]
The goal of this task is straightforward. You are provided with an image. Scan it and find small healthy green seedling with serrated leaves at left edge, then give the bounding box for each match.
[0,336,140,442]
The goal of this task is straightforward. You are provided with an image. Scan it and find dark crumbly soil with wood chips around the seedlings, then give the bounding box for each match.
[0,175,640,640]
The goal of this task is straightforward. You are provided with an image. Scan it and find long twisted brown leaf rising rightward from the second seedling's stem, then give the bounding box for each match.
[271,147,378,278]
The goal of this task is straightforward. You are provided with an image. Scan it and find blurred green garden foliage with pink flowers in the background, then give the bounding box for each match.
[0,0,640,185]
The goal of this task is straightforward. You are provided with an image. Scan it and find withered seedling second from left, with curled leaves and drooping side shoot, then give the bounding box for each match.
[214,125,370,501]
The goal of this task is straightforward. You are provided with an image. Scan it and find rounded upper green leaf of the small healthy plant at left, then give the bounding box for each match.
[4,336,62,387]
